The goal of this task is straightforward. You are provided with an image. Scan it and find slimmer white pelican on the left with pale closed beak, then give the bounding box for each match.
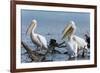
[27,19,48,50]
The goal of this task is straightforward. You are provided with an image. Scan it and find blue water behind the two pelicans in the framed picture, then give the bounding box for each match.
[21,9,90,62]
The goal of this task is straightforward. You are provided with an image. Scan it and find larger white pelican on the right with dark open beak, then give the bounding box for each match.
[62,21,87,57]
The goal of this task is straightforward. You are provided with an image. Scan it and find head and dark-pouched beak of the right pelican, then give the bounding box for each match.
[62,21,76,39]
